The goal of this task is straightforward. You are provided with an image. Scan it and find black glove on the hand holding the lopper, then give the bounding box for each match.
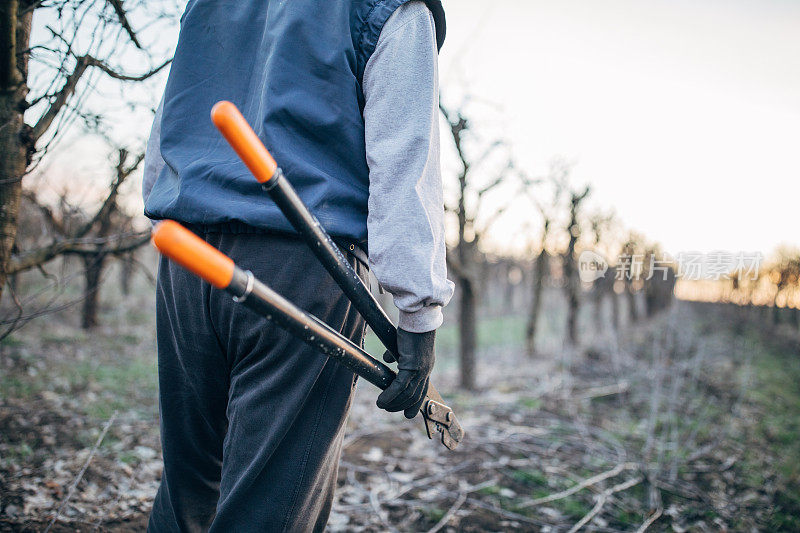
[376,329,436,418]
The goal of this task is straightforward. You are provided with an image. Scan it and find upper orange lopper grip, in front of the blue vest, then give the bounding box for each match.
[211,101,278,184]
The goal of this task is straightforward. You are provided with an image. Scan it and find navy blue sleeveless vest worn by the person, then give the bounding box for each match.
[145,0,445,241]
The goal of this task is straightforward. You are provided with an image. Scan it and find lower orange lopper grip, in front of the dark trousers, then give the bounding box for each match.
[153,220,235,289]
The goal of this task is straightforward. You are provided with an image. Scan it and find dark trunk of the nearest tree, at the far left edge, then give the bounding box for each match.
[0,0,33,304]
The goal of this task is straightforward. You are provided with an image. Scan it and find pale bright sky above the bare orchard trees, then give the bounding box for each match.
[31,0,800,253]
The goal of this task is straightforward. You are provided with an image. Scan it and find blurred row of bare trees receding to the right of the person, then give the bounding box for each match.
[441,106,676,389]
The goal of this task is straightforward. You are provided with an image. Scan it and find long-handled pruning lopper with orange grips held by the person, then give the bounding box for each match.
[153,102,464,450]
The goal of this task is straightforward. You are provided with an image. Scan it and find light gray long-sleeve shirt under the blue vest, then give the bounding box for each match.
[142,0,453,333]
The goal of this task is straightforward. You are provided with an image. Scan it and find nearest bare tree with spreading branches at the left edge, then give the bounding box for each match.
[0,0,169,304]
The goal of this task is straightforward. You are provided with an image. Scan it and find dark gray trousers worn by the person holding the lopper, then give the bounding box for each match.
[148,230,367,532]
